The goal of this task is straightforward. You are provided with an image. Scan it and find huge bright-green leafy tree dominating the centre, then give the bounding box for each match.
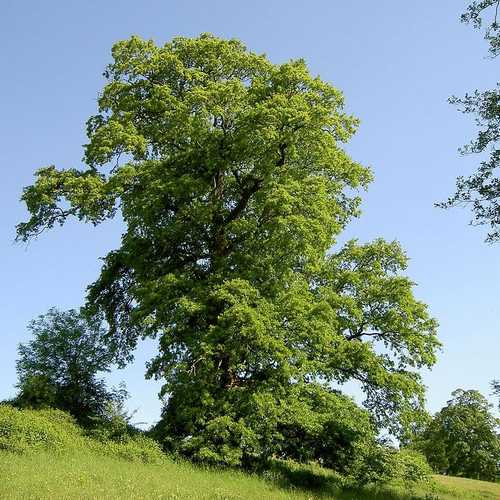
[18,35,438,464]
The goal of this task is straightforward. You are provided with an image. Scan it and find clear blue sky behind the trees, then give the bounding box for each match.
[0,0,500,423]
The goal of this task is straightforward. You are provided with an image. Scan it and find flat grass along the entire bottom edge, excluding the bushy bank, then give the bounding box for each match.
[0,452,500,500]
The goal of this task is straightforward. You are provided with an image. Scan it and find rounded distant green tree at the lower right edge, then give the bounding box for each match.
[417,389,500,481]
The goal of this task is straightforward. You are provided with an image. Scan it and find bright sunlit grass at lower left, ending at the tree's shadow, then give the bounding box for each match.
[0,453,318,499]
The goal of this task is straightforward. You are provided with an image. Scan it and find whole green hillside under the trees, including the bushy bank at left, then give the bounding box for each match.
[0,405,500,500]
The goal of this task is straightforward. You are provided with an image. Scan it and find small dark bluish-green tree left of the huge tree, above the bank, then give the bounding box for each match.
[13,309,127,425]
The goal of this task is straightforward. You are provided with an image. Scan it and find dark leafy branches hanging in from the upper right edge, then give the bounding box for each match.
[438,0,500,241]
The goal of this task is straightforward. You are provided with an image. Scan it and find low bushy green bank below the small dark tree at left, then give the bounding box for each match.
[0,404,164,463]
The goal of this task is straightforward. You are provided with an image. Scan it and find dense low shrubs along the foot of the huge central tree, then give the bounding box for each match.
[151,384,375,473]
